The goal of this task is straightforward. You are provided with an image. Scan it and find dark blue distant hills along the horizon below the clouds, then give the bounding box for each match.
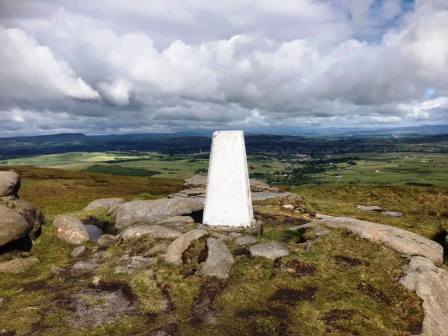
[0,126,448,159]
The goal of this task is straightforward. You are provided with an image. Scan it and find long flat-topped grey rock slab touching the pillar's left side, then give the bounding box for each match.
[115,197,204,230]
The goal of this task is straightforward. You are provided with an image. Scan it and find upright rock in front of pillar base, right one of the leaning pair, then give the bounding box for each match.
[199,238,234,279]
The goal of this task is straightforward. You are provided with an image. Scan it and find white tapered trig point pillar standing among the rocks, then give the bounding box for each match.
[203,131,254,227]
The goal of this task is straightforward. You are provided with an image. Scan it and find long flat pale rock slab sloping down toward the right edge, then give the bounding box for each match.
[320,215,443,265]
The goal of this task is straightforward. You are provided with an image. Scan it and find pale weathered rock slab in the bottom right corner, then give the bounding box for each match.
[400,256,448,336]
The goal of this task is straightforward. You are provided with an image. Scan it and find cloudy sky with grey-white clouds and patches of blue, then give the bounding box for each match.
[0,0,448,136]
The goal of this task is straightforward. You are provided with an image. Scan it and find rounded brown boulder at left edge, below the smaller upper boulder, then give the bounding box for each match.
[0,205,30,247]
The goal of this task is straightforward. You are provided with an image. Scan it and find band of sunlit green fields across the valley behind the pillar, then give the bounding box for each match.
[0,152,448,187]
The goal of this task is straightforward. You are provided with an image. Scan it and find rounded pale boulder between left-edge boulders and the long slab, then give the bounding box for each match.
[53,215,89,245]
